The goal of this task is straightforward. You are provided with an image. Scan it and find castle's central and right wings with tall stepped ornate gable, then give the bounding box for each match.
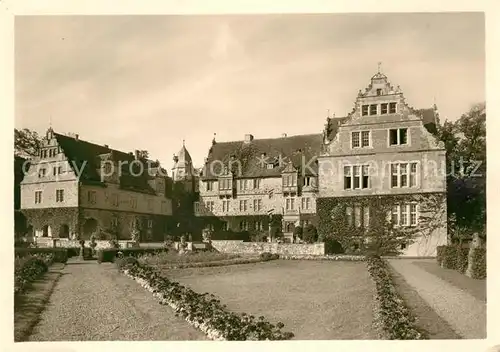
[194,72,447,255]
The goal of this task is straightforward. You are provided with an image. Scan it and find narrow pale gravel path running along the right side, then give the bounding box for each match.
[389,259,486,339]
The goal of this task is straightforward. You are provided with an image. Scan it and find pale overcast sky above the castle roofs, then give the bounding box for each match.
[15,13,485,169]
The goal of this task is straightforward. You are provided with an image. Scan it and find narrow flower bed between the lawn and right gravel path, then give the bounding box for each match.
[367,257,428,340]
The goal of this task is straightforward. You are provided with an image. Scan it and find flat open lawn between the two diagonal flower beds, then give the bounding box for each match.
[163,260,377,340]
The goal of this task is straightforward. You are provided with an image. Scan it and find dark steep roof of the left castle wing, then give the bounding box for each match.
[54,133,158,193]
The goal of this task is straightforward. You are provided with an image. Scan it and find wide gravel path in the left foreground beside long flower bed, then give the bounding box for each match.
[29,260,206,341]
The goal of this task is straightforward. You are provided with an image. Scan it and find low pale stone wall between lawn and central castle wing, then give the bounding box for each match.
[212,241,325,255]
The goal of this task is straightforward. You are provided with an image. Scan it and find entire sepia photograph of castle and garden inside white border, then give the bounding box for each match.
[11,12,486,346]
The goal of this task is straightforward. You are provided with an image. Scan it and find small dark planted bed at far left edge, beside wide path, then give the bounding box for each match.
[14,253,55,295]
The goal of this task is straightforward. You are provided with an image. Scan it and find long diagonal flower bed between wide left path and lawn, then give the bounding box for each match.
[118,258,294,340]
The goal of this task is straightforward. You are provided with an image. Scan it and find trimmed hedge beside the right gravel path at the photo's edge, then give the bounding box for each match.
[436,245,486,279]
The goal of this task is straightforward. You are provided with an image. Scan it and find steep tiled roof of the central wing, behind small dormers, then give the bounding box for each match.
[202,134,323,179]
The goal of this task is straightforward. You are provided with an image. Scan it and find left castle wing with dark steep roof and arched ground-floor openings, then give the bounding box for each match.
[21,128,172,241]
